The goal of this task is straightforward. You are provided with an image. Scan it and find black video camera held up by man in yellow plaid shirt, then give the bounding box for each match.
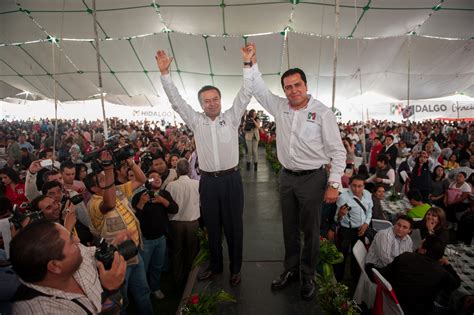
[82,135,135,171]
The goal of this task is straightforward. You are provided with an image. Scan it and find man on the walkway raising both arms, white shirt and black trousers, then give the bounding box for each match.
[156,48,252,286]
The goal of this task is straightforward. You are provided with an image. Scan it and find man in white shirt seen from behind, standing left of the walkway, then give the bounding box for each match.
[166,159,201,283]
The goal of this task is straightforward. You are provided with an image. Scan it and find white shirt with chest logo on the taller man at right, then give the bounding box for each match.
[251,65,346,183]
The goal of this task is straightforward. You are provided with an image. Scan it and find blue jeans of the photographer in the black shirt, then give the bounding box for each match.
[142,235,166,292]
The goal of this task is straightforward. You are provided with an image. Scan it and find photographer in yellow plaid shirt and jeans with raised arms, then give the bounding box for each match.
[84,151,153,314]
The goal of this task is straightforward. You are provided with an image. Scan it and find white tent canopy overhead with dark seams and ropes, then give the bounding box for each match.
[0,0,474,113]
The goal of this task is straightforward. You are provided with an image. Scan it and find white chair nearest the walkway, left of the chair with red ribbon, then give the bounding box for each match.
[352,240,377,308]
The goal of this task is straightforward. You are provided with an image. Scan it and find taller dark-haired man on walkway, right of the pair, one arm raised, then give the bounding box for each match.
[247,44,346,300]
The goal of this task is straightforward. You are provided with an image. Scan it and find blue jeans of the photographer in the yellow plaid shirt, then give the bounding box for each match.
[121,254,153,315]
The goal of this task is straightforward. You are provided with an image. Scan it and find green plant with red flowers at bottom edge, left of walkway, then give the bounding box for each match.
[181,290,237,315]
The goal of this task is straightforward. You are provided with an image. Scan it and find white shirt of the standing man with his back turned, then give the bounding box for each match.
[166,175,201,221]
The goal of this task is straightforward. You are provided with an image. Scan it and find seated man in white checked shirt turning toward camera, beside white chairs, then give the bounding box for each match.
[365,215,413,275]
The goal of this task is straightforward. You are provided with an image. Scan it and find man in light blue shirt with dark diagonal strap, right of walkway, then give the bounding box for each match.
[334,175,372,281]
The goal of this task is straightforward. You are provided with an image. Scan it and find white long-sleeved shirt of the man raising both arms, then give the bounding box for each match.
[161,68,252,172]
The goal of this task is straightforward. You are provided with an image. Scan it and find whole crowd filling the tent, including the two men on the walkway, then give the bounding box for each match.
[0,44,474,314]
